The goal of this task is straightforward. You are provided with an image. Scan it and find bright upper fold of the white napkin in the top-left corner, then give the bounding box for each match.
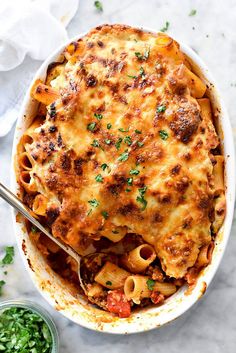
[0,0,78,71]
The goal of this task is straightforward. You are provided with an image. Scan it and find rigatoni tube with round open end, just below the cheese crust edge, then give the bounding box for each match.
[122,244,156,273]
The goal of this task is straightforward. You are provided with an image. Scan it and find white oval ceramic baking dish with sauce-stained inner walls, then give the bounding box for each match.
[11,28,236,334]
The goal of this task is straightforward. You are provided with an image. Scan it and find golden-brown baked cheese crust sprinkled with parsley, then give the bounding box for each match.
[30,25,218,278]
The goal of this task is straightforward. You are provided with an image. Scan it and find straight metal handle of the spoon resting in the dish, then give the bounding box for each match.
[0,183,80,263]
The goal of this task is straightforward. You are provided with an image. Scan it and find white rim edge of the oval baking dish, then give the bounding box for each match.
[11,26,236,334]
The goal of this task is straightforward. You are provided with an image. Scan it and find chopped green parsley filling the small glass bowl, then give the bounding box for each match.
[0,307,52,353]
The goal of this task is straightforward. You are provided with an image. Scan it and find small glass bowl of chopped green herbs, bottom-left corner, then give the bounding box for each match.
[0,301,58,353]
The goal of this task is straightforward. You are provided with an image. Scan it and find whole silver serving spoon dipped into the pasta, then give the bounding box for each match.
[0,183,105,294]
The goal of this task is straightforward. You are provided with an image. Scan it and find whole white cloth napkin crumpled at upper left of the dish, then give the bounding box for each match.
[0,0,79,136]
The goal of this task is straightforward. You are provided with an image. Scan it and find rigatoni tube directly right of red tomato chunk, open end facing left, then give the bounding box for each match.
[124,275,151,304]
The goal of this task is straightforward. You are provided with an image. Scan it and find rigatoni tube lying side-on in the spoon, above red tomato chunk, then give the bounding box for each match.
[95,261,130,289]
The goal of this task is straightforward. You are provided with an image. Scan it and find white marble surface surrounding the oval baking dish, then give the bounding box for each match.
[0,0,236,353]
